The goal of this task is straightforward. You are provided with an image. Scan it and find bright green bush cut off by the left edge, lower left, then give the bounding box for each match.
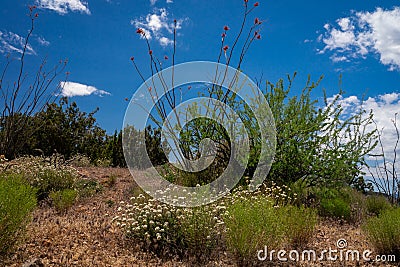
[0,175,36,254]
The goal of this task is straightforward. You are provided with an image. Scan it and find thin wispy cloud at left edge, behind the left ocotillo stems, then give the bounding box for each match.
[0,31,36,55]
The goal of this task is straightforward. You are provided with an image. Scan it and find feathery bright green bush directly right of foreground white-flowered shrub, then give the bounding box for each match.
[224,195,317,266]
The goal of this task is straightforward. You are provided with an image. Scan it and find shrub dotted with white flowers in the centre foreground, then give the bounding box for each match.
[113,194,225,260]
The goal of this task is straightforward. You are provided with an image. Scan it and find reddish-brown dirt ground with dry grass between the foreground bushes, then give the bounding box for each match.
[0,168,397,267]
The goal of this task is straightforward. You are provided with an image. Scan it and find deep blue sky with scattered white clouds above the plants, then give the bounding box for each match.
[0,0,400,138]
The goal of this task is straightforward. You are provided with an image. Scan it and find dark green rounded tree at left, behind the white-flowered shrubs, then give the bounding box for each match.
[26,97,106,161]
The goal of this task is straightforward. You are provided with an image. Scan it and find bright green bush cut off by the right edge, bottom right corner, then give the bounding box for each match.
[363,208,400,260]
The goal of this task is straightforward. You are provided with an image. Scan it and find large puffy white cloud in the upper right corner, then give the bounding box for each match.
[318,7,400,70]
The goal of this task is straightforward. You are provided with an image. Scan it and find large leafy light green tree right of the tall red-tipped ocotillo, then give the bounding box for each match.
[260,73,376,190]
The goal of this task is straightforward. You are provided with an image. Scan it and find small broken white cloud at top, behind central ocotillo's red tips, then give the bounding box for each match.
[131,8,183,46]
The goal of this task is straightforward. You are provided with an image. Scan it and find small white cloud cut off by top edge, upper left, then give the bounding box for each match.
[36,0,90,15]
